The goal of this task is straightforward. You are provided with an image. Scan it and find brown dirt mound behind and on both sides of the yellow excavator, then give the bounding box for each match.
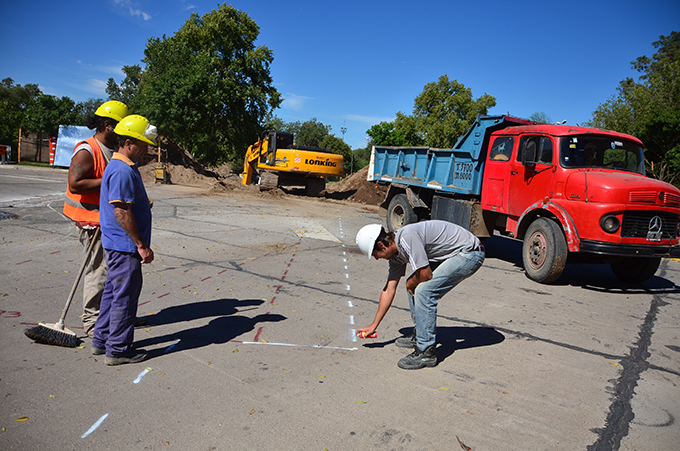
[139,148,387,205]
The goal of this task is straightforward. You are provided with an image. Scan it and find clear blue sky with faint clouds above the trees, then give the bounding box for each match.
[0,0,680,148]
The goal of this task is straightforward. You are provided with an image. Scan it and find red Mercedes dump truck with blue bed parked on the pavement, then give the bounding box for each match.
[368,116,680,283]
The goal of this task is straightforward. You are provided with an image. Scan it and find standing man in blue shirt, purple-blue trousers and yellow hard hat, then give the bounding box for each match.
[92,114,157,365]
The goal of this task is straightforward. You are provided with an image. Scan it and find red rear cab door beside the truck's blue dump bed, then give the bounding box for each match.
[482,136,515,213]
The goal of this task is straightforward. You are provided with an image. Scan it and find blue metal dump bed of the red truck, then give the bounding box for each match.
[368,116,531,195]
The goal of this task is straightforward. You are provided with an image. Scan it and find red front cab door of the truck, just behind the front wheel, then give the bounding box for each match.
[508,135,556,217]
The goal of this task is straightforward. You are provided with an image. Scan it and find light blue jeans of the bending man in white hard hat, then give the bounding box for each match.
[408,250,485,351]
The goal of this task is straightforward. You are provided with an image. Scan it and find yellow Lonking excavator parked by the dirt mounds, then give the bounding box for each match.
[241,130,343,197]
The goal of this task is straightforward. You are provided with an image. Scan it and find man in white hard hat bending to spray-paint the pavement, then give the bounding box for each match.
[356,220,485,370]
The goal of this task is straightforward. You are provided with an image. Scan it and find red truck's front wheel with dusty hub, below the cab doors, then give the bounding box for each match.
[522,218,569,283]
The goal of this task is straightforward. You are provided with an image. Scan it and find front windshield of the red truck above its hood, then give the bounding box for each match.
[560,135,645,175]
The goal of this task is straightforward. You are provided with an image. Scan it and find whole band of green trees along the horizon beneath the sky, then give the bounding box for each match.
[0,4,680,182]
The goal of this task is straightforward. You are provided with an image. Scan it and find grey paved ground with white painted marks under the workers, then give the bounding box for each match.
[0,167,680,451]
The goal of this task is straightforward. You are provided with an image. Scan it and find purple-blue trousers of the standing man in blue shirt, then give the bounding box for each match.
[92,250,142,357]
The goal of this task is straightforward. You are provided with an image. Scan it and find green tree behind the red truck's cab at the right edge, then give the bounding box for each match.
[586,31,680,183]
